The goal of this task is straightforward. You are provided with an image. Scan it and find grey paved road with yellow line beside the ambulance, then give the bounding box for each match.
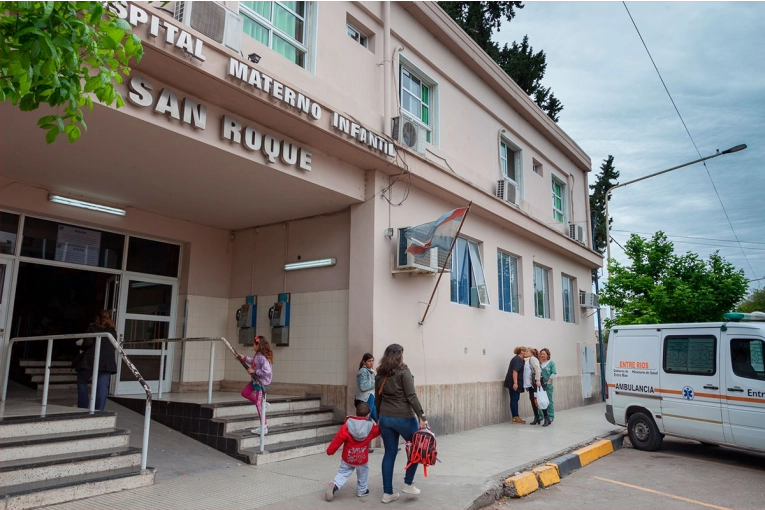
[486,437,765,510]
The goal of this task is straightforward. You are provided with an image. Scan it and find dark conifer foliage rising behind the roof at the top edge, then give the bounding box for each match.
[438,0,563,122]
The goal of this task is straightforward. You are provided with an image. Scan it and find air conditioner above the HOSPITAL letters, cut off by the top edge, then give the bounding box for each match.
[173,0,244,52]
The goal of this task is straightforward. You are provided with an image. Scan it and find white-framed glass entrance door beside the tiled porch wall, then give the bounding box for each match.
[114,273,178,395]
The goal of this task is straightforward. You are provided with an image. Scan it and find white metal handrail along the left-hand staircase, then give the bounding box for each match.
[0,332,154,470]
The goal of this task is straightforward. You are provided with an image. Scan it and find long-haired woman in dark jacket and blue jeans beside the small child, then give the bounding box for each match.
[375,344,428,503]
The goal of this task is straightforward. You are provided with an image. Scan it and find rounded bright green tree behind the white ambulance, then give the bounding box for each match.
[600,232,747,327]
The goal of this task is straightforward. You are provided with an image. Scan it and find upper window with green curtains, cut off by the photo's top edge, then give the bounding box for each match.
[239,0,308,67]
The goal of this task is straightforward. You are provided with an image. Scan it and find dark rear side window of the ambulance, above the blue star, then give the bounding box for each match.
[664,335,717,375]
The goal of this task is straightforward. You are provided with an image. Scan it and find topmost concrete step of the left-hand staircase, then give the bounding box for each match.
[0,411,117,439]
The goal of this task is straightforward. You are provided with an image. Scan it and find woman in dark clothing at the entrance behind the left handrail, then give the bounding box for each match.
[76,310,117,411]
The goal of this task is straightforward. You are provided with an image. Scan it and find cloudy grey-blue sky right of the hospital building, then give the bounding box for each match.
[495,1,765,290]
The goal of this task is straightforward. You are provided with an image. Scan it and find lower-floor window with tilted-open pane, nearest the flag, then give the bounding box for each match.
[451,237,490,307]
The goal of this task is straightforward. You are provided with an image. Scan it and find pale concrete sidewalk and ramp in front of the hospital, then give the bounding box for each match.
[41,404,618,510]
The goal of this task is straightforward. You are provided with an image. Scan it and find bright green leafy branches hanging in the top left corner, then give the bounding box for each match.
[0,0,143,143]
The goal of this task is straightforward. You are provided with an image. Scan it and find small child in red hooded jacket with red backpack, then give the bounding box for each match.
[324,402,380,501]
